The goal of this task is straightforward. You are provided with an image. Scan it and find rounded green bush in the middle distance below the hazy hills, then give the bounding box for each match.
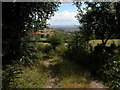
[48,31,64,50]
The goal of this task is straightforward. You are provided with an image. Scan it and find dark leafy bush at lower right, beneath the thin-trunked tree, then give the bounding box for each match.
[90,43,120,90]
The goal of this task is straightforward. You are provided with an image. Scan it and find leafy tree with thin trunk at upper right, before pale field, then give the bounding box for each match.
[75,2,120,46]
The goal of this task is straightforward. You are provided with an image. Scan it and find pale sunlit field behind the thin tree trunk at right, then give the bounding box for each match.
[90,39,120,46]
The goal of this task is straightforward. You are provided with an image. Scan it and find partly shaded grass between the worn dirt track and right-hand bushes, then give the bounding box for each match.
[53,59,90,88]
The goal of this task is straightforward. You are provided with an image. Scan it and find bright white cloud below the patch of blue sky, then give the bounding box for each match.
[48,11,79,25]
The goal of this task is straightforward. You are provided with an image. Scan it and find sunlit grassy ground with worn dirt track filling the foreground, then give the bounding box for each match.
[8,56,106,88]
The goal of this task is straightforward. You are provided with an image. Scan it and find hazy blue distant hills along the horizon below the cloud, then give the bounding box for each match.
[48,25,79,32]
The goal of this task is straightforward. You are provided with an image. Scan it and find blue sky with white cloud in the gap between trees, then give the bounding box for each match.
[48,3,79,25]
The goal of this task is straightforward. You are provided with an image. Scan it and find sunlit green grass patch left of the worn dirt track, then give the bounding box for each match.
[11,61,48,88]
